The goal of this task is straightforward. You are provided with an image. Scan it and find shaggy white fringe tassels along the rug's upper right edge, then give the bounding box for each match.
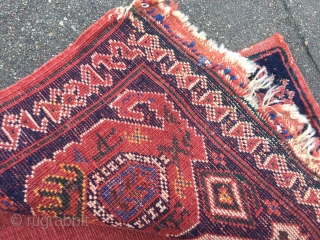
[125,0,320,172]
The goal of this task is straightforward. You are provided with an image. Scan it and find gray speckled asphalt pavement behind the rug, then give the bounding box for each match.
[0,0,320,103]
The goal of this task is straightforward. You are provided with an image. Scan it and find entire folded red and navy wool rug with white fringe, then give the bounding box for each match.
[0,0,320,239]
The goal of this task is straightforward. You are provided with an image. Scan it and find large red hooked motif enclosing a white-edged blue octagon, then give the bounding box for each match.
[25,84,206,234]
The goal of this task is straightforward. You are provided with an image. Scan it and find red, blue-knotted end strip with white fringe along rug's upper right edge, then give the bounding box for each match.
[137,0,320,174]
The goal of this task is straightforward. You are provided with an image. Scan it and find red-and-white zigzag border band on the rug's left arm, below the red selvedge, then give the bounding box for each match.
[0,37,143,150]
